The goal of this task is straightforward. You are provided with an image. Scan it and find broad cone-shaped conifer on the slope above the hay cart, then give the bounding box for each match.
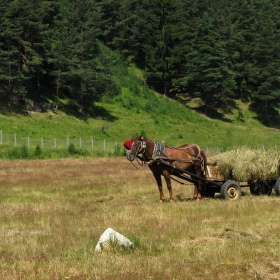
[181,12,235,114]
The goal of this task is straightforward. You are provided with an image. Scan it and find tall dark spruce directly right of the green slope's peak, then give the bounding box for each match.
[137,0,180,95]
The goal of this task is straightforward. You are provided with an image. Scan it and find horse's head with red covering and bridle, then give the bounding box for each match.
[123,136,151,161]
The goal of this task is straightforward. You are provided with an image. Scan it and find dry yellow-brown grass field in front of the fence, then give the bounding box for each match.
[0,157,280,280]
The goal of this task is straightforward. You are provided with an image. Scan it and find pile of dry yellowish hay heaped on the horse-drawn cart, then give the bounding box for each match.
[208,147,280,181]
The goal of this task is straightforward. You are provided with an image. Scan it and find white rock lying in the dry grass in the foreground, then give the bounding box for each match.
[95,228,134,252]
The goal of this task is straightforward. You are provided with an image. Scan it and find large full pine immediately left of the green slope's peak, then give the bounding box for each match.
[49,0,121,113]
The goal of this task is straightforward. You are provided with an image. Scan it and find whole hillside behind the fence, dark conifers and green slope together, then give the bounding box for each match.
[0,0,280,155]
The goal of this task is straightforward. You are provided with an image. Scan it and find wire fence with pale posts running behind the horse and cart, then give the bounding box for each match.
[0,130,280,154]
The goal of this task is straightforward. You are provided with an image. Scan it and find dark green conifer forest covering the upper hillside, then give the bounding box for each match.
[0,0,280,121]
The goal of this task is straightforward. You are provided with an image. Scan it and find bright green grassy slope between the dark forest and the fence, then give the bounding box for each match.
[0,67,280,153]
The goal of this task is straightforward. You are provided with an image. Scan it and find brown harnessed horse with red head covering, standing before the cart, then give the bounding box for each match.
[124,136,207,201]
